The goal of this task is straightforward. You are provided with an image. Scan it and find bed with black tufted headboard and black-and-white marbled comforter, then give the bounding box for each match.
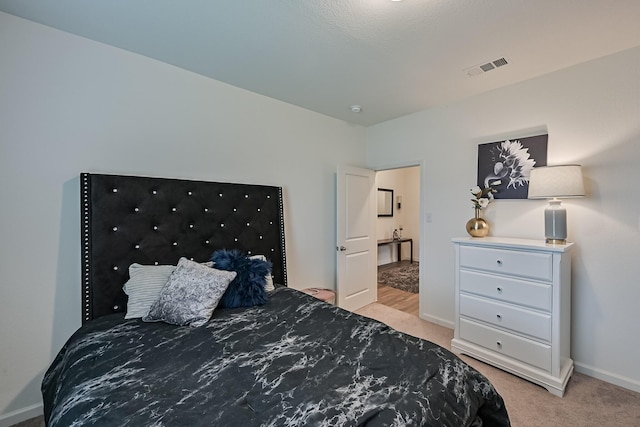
[42,174,509,427]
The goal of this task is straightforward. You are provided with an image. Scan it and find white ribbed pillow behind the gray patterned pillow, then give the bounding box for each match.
[122,262,213,319]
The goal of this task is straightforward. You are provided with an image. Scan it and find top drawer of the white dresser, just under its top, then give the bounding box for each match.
[460,246,553,281]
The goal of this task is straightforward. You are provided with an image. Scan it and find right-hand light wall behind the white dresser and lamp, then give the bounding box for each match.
[367,44,640,391]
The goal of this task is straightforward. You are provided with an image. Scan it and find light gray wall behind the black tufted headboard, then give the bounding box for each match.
[0,13,365,425]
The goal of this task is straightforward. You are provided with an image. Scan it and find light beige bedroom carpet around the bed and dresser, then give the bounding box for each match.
[356,303,640,427]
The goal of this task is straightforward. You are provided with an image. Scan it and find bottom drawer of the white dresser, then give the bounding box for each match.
[460,319,551,372]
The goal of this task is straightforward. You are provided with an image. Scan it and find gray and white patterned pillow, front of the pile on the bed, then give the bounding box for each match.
[142,258,236,327]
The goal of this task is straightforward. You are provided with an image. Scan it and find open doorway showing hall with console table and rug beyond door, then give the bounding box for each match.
[375,166,421,317]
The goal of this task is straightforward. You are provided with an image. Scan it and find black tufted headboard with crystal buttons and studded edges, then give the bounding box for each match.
[80,173,287,323]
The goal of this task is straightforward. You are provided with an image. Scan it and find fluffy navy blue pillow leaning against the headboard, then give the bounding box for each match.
[211,249,271,308]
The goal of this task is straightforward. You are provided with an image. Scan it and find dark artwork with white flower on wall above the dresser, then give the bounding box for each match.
[478,134,549,199]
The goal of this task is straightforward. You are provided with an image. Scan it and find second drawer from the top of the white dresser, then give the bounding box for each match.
[460,270,552,312]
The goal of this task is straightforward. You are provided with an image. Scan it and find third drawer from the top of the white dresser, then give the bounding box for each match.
[460,294,551,342]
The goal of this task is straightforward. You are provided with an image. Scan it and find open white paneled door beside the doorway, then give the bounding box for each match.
[336,166,378,311]
